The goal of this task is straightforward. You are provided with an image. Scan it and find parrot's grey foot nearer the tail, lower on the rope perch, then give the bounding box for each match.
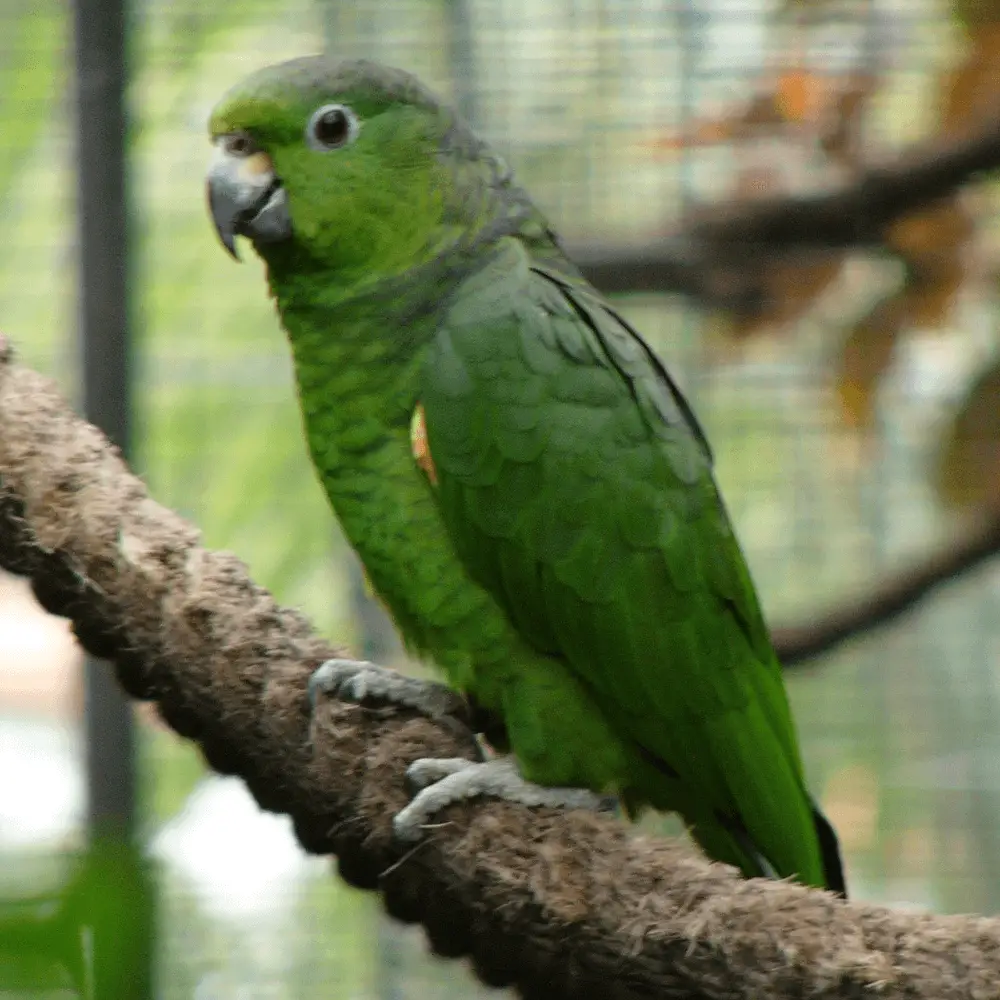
[392,756,617,843]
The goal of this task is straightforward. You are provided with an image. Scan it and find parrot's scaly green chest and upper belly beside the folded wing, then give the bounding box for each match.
[279,282,520,707]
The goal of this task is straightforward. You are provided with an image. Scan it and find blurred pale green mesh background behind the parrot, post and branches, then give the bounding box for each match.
[0,0,1000,1000]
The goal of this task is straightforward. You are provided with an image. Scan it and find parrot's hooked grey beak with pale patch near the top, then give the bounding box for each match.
[208,136,292,260]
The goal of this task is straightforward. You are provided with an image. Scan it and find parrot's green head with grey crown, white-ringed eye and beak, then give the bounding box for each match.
[208,56,501,280]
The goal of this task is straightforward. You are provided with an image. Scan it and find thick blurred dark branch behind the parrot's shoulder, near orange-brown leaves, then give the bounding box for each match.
[571,120,1000,304]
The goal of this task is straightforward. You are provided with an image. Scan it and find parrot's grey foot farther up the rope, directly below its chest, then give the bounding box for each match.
[309,660,468,719]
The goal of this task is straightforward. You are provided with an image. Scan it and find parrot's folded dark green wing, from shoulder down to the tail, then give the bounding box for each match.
[421,240,823,884]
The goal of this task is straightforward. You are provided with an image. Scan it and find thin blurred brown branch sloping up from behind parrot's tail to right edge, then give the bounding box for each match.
[771,511,1000,669]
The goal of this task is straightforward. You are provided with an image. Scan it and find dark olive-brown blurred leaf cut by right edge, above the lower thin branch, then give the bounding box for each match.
[934,362,1000,510]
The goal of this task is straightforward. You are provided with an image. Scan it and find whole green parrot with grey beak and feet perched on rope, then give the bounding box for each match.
[208,56,844,893]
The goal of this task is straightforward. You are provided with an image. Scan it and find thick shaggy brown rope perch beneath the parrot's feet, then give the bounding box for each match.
[0,344,1000,1000]
